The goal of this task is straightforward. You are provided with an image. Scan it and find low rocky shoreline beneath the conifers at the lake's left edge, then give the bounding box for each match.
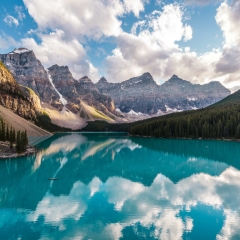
[0,141,37,159]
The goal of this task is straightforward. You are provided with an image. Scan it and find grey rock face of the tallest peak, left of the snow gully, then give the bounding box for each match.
[0,48,61,107]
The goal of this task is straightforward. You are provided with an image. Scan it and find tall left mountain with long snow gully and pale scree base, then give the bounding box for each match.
[0,48,121,130]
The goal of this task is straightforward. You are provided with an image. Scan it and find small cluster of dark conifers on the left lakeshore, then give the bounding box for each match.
[0,118,28,153]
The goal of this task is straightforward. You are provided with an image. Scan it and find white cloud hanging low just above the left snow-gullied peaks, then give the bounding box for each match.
[21,30,99,79]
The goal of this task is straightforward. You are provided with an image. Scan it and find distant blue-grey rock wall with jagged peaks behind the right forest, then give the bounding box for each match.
[96,73,230,114]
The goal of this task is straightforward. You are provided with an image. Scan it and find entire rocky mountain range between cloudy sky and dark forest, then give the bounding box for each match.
[0,48,230,132]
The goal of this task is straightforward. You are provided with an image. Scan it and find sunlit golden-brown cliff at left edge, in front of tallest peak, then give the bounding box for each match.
[0,60,38,121]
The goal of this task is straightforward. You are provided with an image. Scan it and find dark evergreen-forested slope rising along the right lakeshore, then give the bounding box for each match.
[129,90,240,139]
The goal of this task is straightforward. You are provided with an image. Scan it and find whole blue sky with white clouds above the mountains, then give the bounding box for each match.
[0,0,240,87]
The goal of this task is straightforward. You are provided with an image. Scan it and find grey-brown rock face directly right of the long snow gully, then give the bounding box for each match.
[48,65,115,115]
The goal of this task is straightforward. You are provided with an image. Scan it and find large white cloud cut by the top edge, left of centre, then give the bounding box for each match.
[24,0,144,40]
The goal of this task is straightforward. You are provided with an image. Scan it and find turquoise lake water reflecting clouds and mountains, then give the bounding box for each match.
[0,133,240,240]
